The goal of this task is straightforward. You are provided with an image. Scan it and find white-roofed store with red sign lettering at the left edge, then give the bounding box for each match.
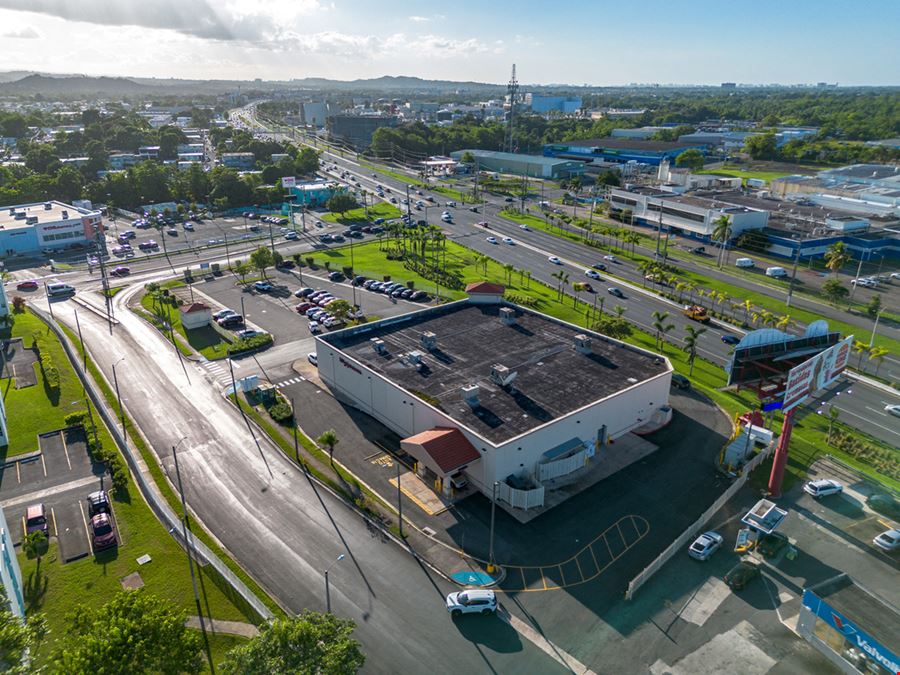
[0,201,103,256]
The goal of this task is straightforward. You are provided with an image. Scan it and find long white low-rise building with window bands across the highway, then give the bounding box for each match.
[609,187,769,241]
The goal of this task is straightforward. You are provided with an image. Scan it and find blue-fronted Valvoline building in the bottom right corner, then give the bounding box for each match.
[797,574,900,675]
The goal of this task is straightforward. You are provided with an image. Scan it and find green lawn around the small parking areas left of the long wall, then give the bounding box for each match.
[5,313,260,665]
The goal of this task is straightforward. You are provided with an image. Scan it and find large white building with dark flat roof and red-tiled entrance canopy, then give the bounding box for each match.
[316,282,672,508]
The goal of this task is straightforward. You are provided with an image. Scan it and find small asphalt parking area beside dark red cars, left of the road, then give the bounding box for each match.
[0,427,118,563]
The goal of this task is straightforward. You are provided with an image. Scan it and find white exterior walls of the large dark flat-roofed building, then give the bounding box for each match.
[316,339,672,491]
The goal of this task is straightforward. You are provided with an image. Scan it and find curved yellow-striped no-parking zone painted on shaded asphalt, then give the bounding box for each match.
[497,515,650,593]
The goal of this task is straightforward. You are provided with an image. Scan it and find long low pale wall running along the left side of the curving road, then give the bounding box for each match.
[32,307,275,621]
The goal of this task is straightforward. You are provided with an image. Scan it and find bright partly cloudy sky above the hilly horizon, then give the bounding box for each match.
[0,0,900,86]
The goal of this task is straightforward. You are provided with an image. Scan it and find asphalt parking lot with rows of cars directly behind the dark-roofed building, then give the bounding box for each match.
[187,268,422,343]
